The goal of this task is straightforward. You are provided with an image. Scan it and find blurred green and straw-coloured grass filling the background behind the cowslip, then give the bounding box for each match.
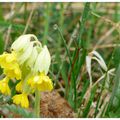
[0,3,120,118]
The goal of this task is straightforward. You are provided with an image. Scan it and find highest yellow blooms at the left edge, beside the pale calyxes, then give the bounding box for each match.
[0,51,21,79]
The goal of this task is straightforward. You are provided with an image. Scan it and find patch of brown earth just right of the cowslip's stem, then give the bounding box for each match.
[41,91,74,118]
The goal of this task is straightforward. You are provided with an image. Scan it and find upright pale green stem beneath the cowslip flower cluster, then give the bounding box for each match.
[34,90,40,118]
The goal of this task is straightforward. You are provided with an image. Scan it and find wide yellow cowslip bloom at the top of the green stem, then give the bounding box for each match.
[28,73,53,92]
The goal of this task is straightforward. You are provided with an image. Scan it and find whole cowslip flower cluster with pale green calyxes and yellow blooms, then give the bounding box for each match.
[0,34,53,108]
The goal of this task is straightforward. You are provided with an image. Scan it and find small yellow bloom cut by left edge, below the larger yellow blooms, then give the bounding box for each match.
[0,77,11,95]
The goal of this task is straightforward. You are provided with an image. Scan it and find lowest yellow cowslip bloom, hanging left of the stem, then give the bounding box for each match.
[12,93,29,108]
